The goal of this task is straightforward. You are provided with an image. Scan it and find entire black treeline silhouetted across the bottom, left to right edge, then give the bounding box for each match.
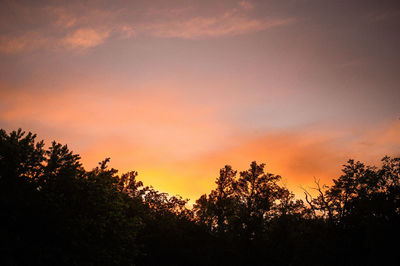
[0,130,400,265]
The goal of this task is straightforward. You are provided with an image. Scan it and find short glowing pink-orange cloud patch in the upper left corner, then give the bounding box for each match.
[0,4,122,54]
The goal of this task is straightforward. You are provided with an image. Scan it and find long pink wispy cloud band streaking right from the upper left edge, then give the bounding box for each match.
[0,1,292,54]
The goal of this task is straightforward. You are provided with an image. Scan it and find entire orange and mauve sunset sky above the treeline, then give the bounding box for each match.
[0,0,400,202]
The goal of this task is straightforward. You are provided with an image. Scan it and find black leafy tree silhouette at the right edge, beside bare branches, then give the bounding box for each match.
[309,157,400,265]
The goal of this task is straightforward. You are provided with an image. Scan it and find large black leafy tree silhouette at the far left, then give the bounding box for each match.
[0,130,140,265]
